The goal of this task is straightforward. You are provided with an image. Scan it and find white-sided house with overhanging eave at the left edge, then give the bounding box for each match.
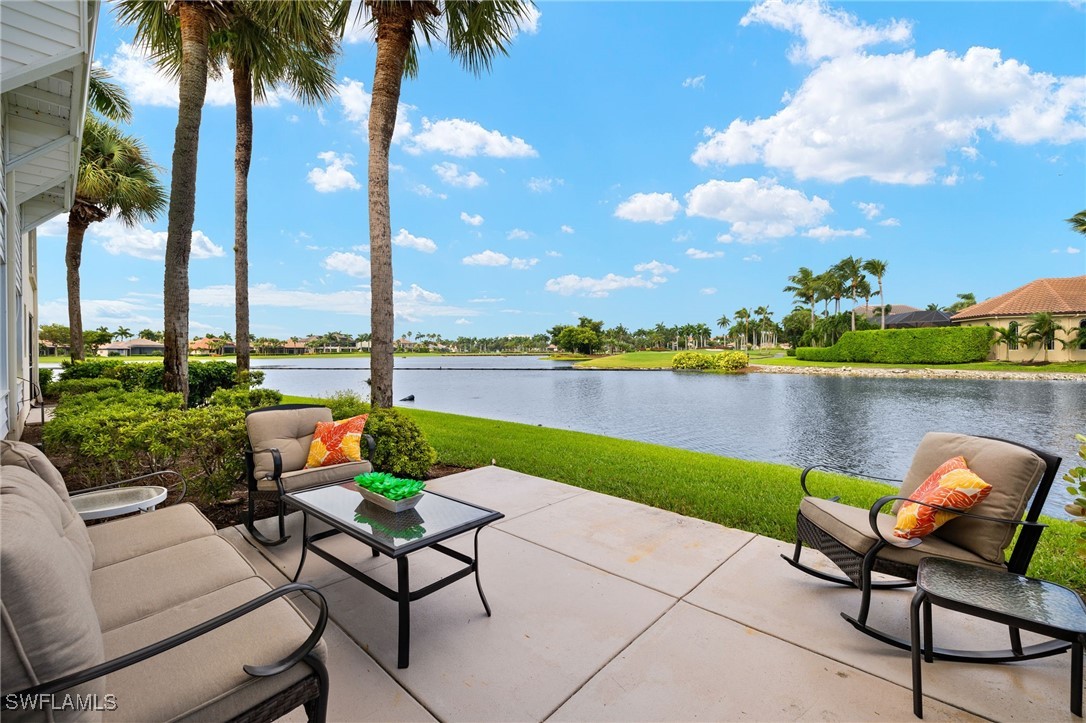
[0,0,99,439]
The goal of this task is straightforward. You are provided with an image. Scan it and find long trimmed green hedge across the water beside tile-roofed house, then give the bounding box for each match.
[796,327,994,364]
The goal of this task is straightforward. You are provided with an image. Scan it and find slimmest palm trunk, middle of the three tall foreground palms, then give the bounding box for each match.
[233,63,253,375]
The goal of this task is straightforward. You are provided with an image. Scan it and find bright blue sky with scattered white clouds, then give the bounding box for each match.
[39,2,1086,338]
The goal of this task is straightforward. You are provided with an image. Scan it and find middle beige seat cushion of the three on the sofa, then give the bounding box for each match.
[90,534,256,632]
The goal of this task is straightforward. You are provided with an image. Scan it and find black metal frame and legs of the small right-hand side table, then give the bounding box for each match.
[909,563,1086,719]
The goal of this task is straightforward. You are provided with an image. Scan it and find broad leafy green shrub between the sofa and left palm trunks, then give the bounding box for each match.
[43,388,245,500]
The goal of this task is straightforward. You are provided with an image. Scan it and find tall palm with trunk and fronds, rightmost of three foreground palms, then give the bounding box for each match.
[338,0,530,407]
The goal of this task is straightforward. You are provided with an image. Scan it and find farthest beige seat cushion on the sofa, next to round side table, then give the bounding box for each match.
[87,504,215,569]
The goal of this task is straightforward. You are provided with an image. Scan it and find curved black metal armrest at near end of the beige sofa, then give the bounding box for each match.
[3,583,328,697]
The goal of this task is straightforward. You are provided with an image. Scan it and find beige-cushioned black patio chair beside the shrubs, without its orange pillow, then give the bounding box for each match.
[245,404,375,547]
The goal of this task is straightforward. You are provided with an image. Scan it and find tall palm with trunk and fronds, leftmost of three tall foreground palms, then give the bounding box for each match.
[117,0,226,399]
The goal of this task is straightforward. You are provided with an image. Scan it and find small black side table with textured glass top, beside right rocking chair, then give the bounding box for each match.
[909,557,1086,718]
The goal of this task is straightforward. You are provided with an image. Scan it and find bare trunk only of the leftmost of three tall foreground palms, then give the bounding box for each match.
[162,2,211,405]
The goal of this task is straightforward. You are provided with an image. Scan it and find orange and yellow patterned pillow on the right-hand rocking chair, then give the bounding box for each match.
[894,457,992,540]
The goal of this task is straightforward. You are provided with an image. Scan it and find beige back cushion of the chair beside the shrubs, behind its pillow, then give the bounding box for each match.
[245,407,332,489]
